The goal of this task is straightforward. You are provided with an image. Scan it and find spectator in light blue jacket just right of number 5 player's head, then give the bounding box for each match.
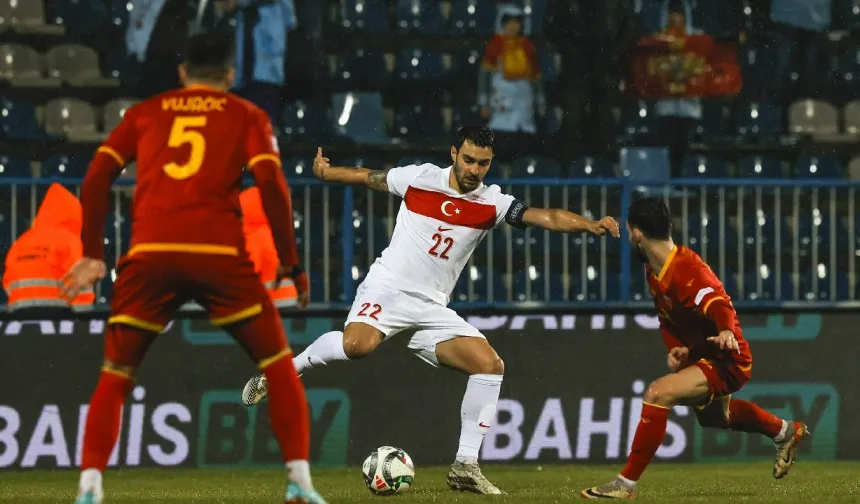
[227,0,298,127]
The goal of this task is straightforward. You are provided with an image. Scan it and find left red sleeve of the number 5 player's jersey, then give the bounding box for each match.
[81,107,138,259]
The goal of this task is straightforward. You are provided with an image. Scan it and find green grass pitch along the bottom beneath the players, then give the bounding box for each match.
[0,460,860,504]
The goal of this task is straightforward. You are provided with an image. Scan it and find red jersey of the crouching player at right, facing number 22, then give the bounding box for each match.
[645,246,752,367]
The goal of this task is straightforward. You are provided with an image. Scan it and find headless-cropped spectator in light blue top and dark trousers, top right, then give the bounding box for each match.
[770,0,832,98]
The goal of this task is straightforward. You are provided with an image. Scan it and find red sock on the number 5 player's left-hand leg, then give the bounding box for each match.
[81,371,134,472]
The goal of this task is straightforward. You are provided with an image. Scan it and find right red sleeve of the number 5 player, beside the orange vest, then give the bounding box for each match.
[245,108,299,267]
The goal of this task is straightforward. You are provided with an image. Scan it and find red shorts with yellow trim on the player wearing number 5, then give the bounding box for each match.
[108,252,280,333]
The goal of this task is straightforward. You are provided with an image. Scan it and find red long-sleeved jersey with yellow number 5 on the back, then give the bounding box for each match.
[82,86,295,259]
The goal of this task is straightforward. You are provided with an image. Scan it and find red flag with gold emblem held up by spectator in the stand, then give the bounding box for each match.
[632,35,743,98]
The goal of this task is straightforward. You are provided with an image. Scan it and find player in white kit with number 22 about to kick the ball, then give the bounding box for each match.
[242,126,619,494]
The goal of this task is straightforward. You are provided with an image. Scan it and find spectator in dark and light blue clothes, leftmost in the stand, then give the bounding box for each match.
[125,0,195,98]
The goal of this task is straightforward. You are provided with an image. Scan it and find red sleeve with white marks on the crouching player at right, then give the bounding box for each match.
[674,260,740,334]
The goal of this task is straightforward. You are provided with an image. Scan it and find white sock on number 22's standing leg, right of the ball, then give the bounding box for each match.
[456,374,502,464]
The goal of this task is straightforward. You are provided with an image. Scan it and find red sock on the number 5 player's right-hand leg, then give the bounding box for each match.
[263,355,310,462]
